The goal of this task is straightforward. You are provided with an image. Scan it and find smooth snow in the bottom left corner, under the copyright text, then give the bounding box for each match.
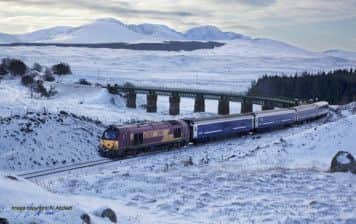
[0,175,157,224]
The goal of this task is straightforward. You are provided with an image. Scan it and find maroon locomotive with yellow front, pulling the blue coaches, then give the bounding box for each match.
[100,120,189,157]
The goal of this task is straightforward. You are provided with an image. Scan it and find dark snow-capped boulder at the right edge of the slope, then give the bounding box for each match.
[330,151,356,174]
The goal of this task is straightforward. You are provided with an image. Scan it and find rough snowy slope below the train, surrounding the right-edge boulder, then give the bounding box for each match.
[40,115,356,223]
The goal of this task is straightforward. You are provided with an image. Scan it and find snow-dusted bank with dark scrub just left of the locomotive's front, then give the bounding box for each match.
[0,112,104,171]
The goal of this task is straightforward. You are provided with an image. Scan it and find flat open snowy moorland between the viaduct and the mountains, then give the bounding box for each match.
[0,39,356,92]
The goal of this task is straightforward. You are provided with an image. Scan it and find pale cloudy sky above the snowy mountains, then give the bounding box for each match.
[0,0,356,51]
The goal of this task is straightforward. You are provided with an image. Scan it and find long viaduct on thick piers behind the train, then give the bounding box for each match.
[107,84,298,115]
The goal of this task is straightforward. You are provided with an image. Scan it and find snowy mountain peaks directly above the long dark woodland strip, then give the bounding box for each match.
[0,18,244,43]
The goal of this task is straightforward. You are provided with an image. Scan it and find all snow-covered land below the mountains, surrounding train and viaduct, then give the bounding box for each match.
[0,34,356,223]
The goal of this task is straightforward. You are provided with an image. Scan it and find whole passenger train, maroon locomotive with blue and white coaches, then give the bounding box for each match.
[99,101,329,158]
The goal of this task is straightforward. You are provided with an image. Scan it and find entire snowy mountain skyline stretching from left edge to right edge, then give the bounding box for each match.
[0,18,356,57]
